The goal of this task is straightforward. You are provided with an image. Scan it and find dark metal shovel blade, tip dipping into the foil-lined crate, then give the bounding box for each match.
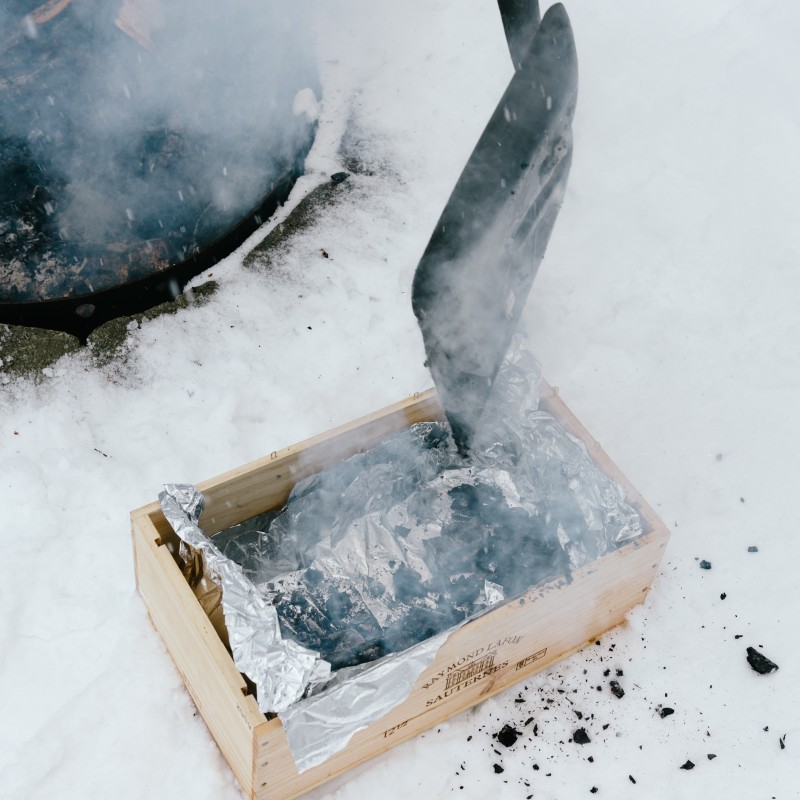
[412,4,578,454]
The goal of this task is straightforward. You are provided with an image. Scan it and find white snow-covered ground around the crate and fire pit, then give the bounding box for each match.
[0,0,800,800]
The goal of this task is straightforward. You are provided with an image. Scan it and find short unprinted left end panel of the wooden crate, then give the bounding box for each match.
[132,515,264,792]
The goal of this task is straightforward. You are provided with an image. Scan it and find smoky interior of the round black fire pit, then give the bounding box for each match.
[0,0,319,302]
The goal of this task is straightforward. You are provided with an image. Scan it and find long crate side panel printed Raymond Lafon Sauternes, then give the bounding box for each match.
[254,533,666,800]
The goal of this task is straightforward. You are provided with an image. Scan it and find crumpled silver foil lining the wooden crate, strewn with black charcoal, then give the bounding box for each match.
[161,335,641,771]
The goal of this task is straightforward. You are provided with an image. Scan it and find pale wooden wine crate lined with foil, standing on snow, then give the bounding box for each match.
[131,386,669,800]
